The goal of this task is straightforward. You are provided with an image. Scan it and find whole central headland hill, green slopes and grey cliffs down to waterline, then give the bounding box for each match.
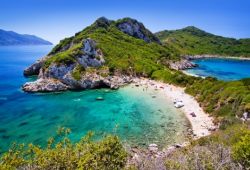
[23,18,179,91]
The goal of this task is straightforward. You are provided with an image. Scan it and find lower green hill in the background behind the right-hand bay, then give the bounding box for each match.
[155,26,250,57]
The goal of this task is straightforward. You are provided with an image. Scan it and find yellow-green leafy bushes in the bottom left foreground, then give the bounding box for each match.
[0,128,127,170]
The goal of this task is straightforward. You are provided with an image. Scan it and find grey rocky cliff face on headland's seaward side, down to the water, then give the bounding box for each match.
[22,38,131,92]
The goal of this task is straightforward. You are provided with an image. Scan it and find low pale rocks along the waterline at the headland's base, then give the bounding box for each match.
[22,74,132,92]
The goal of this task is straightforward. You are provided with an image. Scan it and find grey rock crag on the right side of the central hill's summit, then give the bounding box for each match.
[116,18,160,44]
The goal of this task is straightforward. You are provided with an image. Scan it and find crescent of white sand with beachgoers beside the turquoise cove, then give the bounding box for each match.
[134,79,215,139]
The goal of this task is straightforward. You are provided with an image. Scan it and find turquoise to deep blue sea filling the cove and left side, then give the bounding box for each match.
[0,46,189,151]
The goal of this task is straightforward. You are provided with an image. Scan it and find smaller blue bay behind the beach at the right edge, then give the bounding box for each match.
[186,58,250,81]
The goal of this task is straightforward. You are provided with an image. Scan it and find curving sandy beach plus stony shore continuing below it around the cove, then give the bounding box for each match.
[127,78,217,167]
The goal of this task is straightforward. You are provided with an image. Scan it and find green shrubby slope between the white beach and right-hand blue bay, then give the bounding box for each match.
[186,78,250,127]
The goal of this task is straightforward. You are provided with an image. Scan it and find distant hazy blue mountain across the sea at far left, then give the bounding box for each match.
[0,29,52,46]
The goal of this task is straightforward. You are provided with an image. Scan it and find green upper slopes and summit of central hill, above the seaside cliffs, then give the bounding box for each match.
[47,18,178,75]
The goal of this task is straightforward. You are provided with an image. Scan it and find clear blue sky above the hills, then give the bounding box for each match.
[0,0,250,44]
